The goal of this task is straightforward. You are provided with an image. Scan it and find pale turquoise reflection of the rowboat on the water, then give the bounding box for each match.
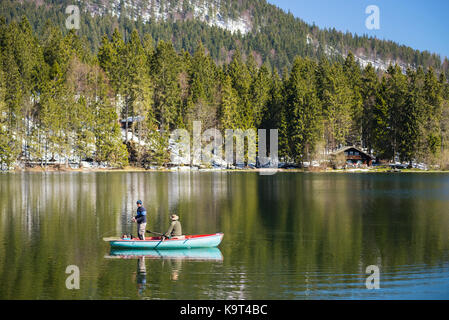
[105,248,223,261]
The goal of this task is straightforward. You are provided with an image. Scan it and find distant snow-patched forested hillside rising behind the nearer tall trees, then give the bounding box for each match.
[0,0,449,76]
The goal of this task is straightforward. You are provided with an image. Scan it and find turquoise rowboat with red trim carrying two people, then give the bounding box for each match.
[103,233,223,250]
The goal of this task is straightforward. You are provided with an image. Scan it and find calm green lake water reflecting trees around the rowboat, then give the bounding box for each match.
[0,172,449,299]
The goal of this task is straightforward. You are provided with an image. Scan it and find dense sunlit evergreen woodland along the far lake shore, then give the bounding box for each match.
[0,17,449,170]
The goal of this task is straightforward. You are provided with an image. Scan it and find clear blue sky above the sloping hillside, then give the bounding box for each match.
[267,0,449,58]
